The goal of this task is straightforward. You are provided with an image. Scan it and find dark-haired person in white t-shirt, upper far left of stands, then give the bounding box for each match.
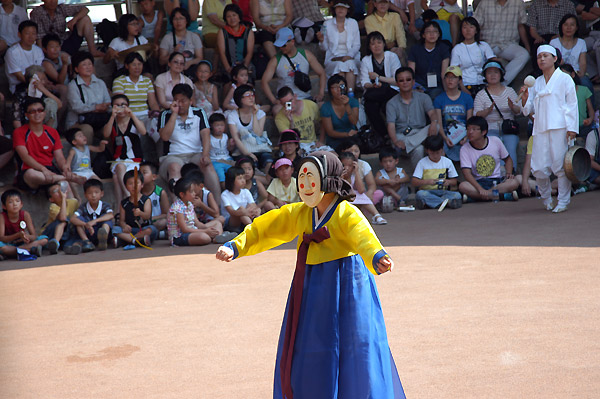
[5,20,44,93]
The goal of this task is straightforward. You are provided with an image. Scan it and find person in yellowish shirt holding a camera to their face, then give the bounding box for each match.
[275,86,325,154]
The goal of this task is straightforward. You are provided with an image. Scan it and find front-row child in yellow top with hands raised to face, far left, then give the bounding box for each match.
[42,183,81,255]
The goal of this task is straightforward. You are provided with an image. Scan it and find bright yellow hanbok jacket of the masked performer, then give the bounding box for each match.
[227,201,383,274]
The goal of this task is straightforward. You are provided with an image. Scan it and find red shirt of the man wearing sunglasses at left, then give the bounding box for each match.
[13,125,62,170]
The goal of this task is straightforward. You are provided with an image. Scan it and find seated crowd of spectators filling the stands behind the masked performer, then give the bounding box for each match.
[0,0,600,257]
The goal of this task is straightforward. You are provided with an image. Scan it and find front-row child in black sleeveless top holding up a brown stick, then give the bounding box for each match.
[113,170,158,249]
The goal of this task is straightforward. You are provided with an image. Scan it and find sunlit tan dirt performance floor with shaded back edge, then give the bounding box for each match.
[0,192,600,399]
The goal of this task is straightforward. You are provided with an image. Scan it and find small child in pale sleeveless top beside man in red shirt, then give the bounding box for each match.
[65,127,108,185]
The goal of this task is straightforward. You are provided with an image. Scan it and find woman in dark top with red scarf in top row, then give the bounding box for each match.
[216,4,254,74]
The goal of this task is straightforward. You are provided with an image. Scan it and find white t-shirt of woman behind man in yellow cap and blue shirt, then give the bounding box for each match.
[450,42,496,86]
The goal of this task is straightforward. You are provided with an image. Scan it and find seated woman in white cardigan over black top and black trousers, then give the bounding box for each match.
[360,31,401,142]
